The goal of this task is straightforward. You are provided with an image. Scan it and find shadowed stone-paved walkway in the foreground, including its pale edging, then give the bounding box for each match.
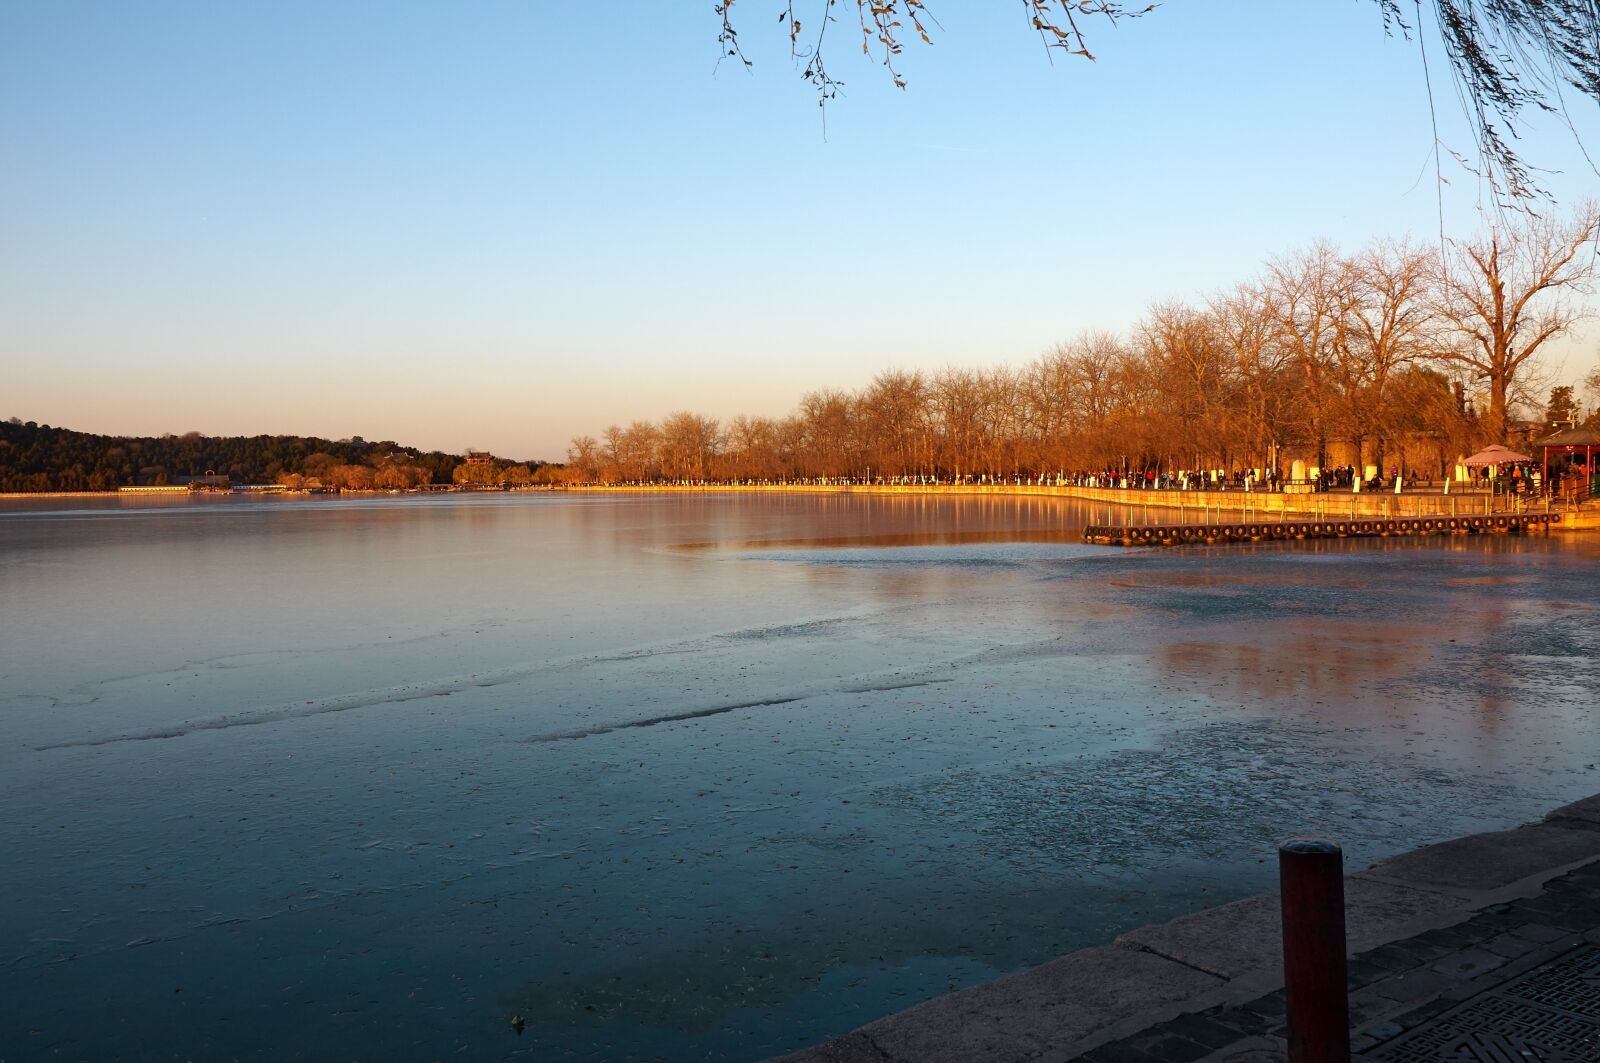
[768,796,1600,1063]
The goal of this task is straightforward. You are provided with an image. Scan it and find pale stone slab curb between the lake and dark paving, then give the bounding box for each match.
[770,794,1600,1063]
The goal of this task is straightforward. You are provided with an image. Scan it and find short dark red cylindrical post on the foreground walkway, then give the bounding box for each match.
[1278,837,1350,1063]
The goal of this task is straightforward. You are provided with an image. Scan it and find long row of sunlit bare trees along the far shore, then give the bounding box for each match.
[568,205,1600,482]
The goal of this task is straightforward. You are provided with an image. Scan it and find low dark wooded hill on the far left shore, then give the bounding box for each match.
[0,418,541,491]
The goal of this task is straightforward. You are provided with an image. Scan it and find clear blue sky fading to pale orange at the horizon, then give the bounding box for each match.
[0,0,1600,458]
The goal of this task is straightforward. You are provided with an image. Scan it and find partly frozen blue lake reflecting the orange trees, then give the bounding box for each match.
[0,495,1600,1061]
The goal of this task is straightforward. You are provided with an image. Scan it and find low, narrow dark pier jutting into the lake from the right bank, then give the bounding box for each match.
[1083,514,1562,546]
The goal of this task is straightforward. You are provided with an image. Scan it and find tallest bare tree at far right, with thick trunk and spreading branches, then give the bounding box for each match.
[1435,203,1600,439]
